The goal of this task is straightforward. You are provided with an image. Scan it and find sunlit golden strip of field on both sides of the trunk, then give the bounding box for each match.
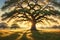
[0,29,60,32]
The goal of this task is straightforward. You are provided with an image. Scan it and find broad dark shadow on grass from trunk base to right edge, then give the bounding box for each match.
[31,30,60,40]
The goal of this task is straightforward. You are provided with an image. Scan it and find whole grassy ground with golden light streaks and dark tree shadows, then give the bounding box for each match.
[0,30,60,40]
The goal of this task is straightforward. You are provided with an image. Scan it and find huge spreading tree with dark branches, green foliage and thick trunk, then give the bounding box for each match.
[2,0,60,30]
